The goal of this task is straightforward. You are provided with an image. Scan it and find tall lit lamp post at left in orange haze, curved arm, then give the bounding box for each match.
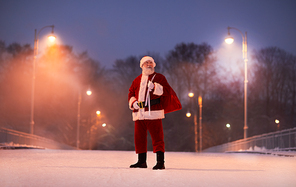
[30,25,56,134]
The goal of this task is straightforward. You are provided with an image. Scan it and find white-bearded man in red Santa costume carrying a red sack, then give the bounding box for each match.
[128,56,182,169]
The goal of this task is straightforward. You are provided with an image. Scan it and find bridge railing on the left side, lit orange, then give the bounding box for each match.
[0,127,76,149]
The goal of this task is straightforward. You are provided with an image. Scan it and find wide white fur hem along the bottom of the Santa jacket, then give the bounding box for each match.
[132,109,164,121]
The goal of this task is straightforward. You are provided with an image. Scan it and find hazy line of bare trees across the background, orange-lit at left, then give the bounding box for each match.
[0,41,296,151]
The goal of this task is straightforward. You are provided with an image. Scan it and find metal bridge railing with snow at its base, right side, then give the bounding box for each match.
[203,128,296,152]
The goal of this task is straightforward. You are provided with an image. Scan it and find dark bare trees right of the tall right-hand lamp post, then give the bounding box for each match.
[250,47,295,133]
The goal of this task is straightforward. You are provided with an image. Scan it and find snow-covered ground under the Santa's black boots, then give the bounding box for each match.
[0,149,296,187]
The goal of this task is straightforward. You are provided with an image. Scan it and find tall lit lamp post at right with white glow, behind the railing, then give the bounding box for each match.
[225,27,248,139]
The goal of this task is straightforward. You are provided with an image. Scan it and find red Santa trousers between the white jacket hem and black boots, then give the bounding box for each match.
[135,119,164,154]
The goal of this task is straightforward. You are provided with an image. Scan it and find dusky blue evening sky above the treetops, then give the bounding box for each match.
[0,0,296,68]
